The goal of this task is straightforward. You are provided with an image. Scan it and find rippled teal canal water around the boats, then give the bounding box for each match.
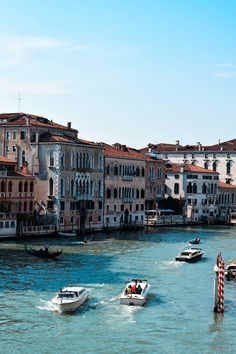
[0,227,236,354]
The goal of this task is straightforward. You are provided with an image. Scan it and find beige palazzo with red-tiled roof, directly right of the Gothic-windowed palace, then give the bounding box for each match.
[101,143,146,229]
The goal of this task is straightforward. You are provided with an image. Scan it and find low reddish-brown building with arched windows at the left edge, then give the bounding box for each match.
[0,156,35,236]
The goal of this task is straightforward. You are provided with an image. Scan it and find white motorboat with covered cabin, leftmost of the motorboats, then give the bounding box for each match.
[51,286,89,312]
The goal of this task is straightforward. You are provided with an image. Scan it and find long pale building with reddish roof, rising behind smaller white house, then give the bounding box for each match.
[140,139,236,184]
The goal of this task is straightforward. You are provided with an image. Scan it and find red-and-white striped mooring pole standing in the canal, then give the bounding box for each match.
[214,254,225,313]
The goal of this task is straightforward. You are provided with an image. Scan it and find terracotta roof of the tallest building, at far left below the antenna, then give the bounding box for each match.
[0,113,77,132]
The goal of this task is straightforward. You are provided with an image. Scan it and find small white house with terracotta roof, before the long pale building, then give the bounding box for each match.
[166,163,219,223]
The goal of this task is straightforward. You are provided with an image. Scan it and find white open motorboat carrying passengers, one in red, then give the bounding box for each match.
[120,279,150,306]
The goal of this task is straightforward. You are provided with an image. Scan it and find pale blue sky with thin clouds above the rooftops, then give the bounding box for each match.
[0,0,236,148]
